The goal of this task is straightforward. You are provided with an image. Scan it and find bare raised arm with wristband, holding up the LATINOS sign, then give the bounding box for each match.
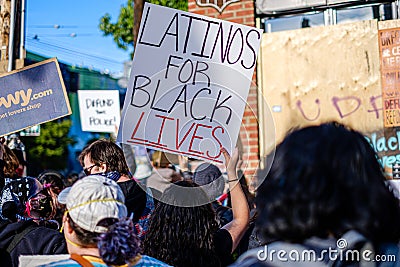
[221,148,250,252]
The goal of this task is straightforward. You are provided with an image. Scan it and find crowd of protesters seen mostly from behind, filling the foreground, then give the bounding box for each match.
[0,122,400,267]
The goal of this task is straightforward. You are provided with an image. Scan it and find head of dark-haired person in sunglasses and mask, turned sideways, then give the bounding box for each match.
[79,139,131,177]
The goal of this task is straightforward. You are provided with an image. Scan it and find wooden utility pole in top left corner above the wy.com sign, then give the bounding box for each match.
[0,0,25,74]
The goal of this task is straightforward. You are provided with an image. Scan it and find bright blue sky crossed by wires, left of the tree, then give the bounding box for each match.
[25,0,130,76]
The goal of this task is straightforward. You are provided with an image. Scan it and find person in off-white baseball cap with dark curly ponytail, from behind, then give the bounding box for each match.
[43,175,168,267]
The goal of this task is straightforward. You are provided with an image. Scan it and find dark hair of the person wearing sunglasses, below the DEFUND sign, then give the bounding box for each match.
[79,139,132,177]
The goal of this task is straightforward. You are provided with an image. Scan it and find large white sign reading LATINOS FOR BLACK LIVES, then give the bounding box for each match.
[118,3,262,162]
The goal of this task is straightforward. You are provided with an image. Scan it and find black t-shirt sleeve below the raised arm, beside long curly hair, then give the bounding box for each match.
[214,229,233,266]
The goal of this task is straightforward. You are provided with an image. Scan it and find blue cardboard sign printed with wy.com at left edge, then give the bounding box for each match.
[0,59,71,136]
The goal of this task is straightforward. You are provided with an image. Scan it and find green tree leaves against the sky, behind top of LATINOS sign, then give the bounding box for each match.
[99,0,188,57]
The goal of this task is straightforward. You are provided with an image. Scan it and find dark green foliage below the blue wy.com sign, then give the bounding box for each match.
[21,120,76,172]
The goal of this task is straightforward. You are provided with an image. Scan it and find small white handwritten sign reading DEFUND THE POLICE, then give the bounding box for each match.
[78,90,121,133]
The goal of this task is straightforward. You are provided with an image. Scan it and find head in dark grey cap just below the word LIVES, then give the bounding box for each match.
[192,163,225,201]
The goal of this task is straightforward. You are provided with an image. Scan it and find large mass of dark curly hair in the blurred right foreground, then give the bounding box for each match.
[256,122,400,246]
